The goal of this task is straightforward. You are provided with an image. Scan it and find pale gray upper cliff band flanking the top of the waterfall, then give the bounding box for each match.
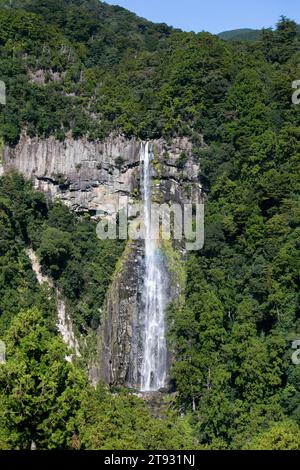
[3,135,199,214]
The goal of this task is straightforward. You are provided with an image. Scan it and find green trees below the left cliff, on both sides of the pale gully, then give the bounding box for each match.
[0,173,124,332]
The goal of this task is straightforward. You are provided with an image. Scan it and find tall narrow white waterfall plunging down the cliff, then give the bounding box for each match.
[141,143,167,392]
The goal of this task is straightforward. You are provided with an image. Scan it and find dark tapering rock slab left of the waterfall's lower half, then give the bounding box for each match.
[90,242,144,388]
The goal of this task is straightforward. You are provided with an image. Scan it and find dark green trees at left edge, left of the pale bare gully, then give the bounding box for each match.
[0,171,56,337]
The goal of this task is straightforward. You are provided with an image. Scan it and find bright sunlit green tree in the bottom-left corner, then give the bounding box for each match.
[0,309,86,449]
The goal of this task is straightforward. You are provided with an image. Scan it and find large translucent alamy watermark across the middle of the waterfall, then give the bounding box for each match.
[97,196,204,251]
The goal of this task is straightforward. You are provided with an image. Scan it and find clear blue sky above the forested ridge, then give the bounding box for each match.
[106,0,300,33]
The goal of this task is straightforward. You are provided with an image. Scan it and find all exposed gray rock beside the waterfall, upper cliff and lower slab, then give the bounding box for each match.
[0,135,202,388]
